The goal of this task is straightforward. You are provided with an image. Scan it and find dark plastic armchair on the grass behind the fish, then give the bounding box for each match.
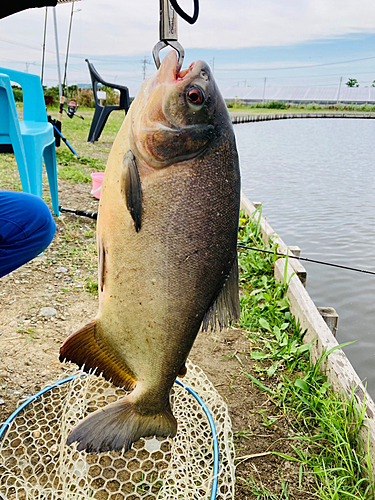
[85,59,130,142]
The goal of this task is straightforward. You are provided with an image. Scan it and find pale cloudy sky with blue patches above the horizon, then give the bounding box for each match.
[0,0,375,96]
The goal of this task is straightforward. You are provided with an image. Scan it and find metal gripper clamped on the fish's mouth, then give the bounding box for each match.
[152,0,185,74]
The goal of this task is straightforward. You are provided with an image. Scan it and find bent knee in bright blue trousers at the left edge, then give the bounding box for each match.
[0,191,56,278]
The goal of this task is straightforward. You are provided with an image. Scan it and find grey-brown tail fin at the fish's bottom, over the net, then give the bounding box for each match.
[67,395,177,453]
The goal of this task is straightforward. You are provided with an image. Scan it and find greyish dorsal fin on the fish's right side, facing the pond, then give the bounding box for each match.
[202,256,241,331]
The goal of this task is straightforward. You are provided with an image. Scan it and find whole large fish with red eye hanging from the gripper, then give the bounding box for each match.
[60,51,241,453]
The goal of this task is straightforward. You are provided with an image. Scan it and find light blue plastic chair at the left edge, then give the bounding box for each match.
[0,67,59,215]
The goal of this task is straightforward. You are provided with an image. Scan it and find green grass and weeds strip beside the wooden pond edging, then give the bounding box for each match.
[239,208,374,500]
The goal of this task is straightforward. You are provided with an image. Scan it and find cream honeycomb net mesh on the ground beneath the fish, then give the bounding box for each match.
[0,361,234,500]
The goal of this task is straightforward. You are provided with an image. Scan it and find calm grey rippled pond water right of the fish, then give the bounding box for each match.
[234,118,375,398]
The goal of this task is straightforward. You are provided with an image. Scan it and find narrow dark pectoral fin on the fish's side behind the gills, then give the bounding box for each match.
[124,151,142,233]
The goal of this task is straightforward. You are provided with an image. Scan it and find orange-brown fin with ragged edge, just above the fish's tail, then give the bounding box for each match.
[60,320,137,390]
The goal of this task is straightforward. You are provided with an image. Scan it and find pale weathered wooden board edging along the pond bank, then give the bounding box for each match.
[241,193,375,471]
